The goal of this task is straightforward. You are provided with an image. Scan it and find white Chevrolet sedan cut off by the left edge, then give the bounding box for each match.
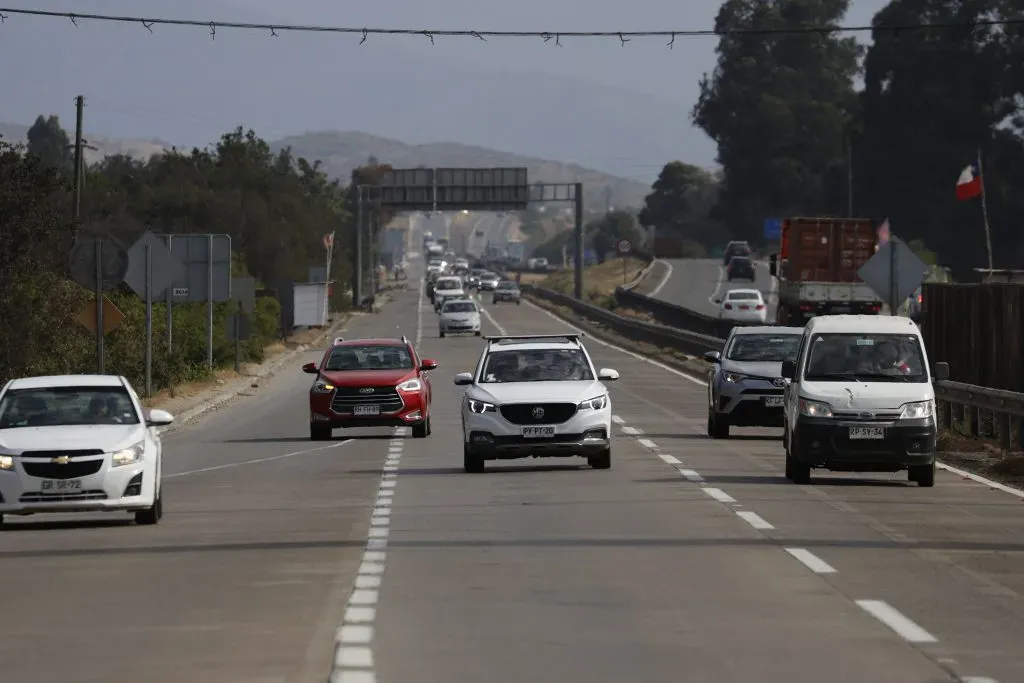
[0,375,174,524]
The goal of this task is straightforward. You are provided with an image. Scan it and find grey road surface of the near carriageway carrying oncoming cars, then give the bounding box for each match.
[0,264,1024,683]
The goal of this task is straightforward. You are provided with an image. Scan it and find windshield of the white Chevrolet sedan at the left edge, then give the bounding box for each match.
[0,386,139,429]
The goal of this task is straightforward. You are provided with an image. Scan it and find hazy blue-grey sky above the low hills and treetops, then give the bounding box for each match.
[0,0,885,176]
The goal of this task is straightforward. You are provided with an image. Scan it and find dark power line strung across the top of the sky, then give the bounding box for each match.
[0,7,1024,48]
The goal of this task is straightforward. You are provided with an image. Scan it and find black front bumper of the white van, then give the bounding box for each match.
[792,416,937,472]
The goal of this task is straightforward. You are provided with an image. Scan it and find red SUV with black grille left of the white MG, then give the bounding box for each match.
[302,337,437,441]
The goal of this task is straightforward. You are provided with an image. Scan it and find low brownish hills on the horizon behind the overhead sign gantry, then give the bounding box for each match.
[0,123,650,210]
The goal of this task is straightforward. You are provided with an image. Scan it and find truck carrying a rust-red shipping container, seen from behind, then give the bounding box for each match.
[769,218,882,327]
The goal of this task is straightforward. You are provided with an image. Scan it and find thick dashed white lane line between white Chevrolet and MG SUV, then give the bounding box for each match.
[330,428,407,683]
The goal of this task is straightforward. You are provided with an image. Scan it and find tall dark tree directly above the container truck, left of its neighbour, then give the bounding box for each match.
[693,0,859,241]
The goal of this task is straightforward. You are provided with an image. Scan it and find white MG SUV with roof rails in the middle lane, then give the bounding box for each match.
[455,334,618,472]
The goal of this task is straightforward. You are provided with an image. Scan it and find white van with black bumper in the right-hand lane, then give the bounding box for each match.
[781,315,949,486]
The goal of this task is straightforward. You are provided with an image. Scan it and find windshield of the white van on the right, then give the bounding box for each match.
[804,334,929,382]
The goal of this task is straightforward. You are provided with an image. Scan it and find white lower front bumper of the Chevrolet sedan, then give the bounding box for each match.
[0,455,157,515]
